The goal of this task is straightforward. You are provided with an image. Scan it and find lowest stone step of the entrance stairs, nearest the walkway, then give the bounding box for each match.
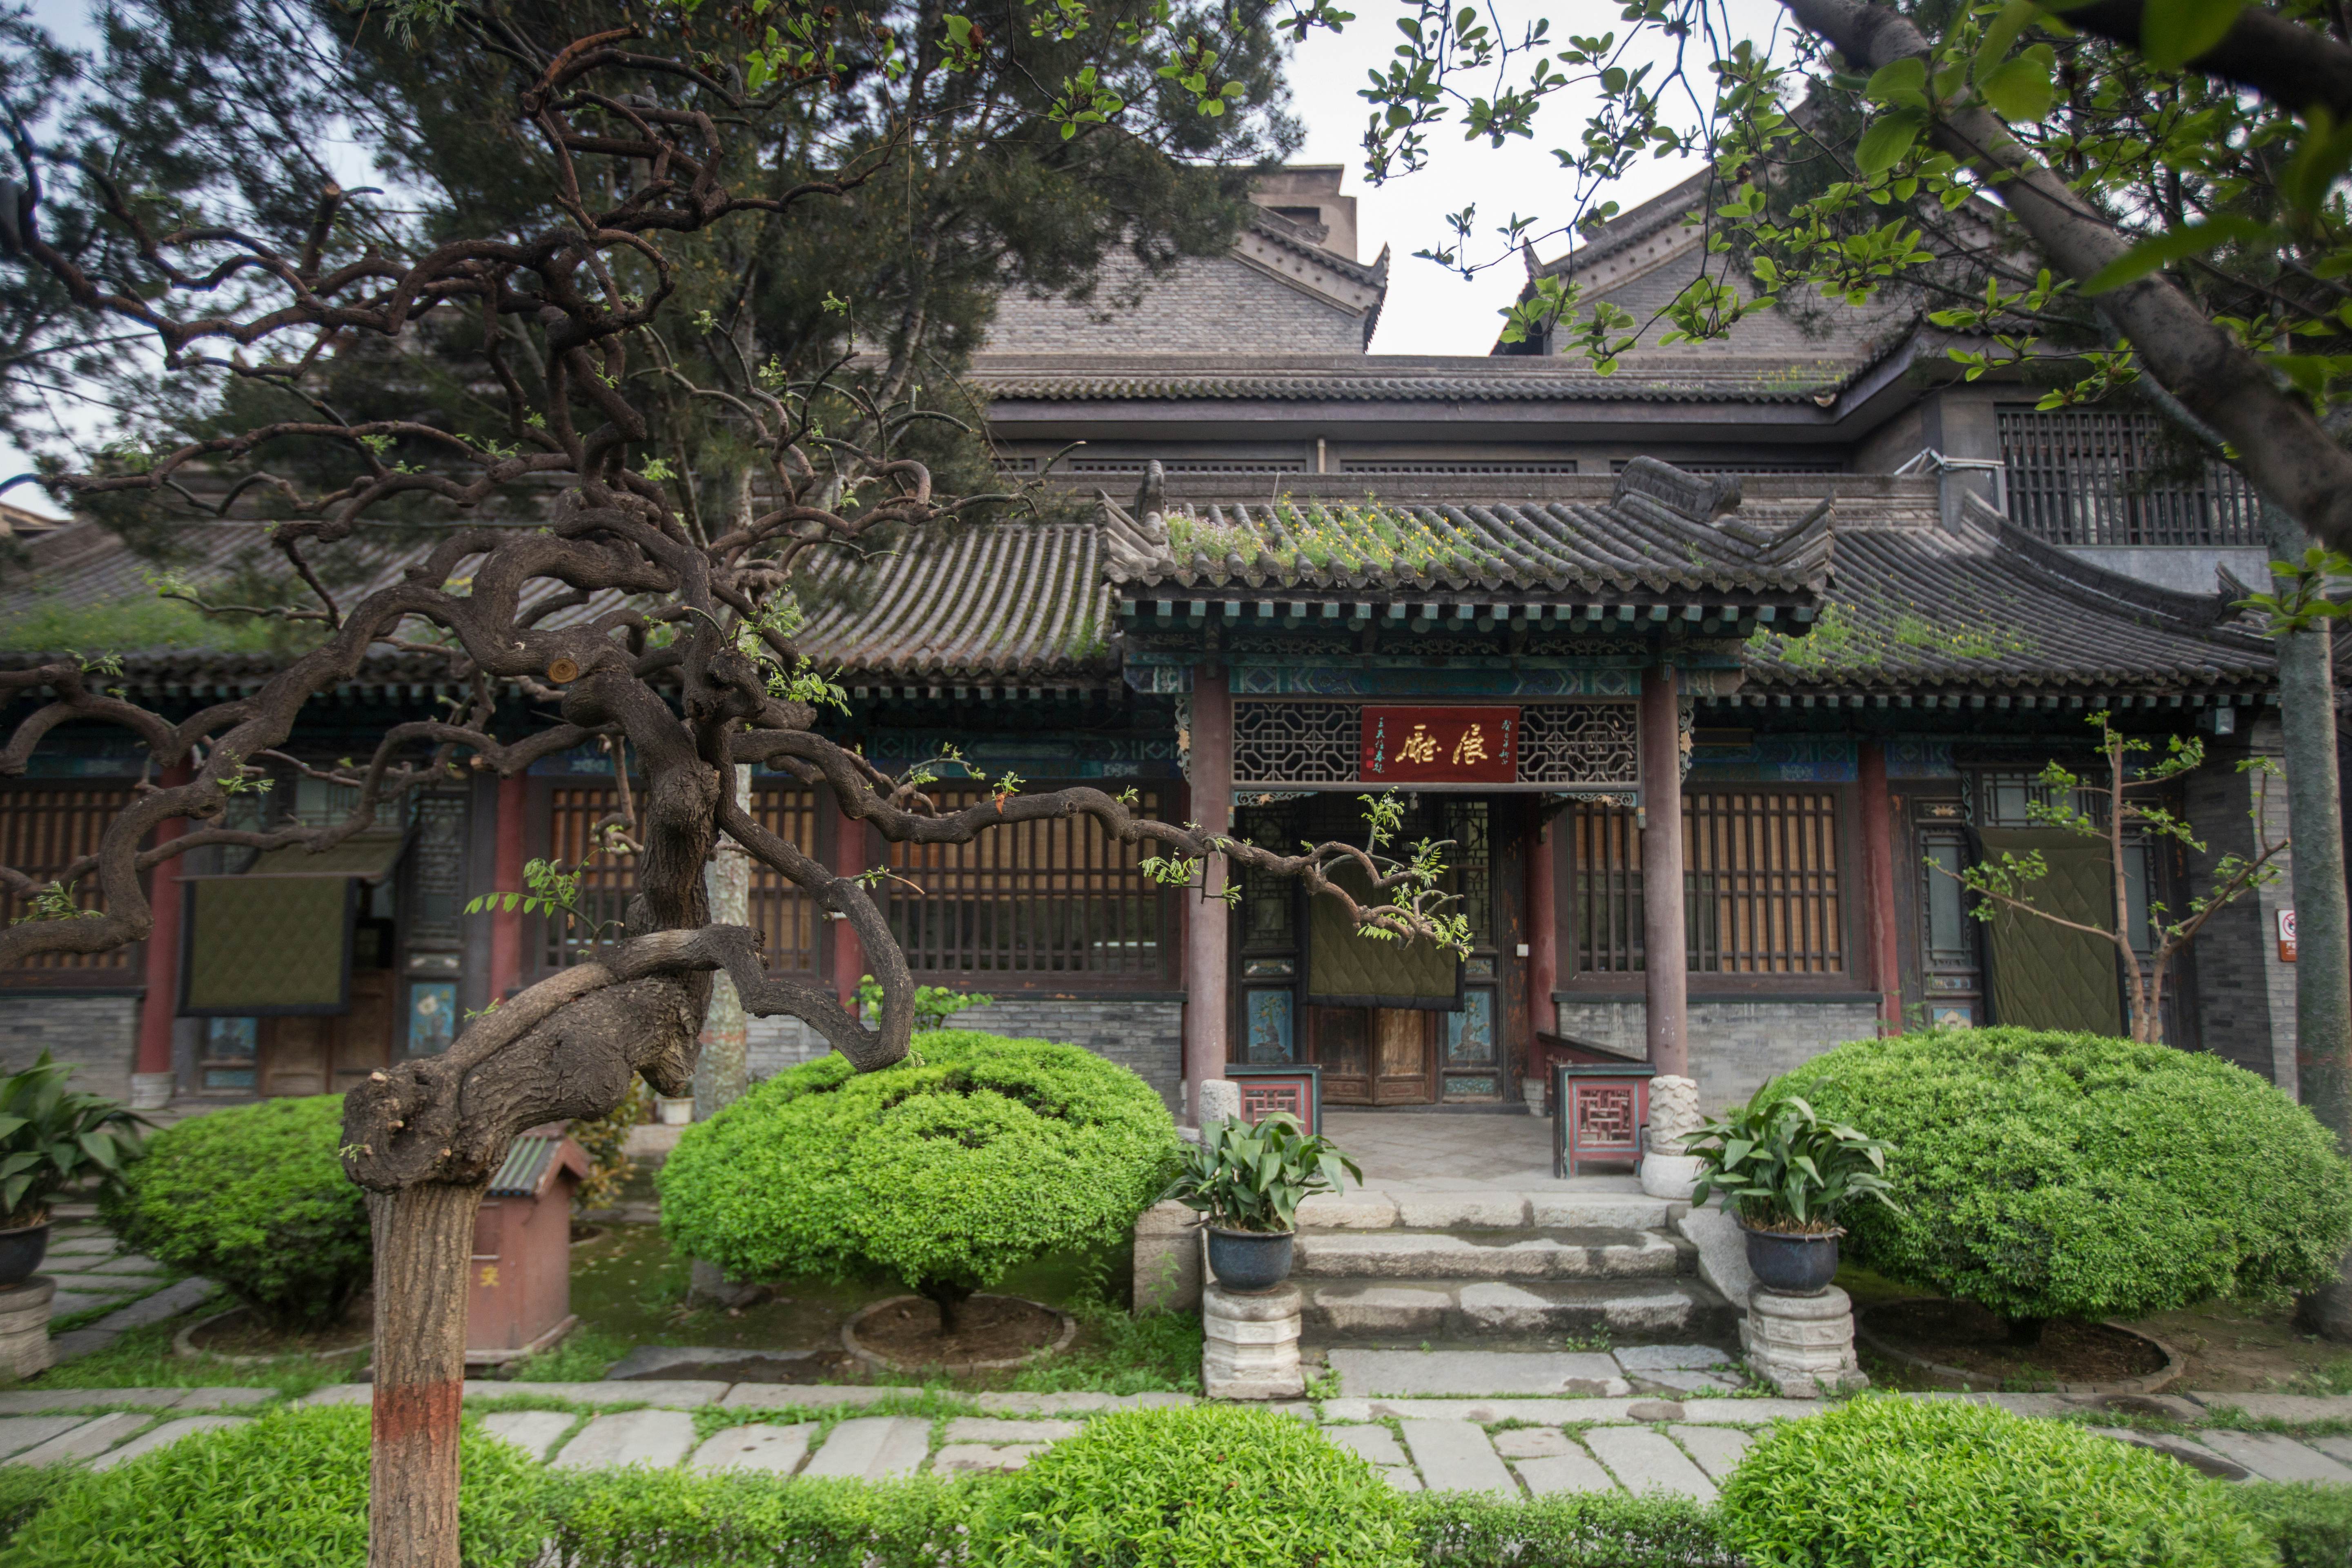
[1298,1274,1738,1345]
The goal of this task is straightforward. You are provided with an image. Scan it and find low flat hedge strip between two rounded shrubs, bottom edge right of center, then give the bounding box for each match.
[1406,1493,1743,1568]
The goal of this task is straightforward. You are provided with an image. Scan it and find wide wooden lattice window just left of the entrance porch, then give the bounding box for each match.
[882,785,1171,982]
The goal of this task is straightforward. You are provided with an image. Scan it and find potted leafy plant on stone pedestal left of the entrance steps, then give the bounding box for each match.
[1160,1112,1364,1291]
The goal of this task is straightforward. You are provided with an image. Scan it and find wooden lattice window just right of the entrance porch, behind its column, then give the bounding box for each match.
[1569,788,1846,976]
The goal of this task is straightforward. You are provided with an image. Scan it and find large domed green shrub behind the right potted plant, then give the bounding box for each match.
[1783,1030,2352,1321]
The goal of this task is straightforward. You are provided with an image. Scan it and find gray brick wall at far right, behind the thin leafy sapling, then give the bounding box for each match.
[2183,719,2296,1093]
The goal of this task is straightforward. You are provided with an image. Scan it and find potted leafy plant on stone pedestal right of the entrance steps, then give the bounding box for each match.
[1684,1079,1896,1295]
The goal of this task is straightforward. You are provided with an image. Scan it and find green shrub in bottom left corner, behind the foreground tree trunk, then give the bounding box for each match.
[7,1406,548,1568]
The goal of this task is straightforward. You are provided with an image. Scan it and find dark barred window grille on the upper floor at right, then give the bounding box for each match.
[1997,407,2263,546]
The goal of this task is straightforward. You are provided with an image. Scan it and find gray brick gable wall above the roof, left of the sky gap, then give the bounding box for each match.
[988,256,1364,355]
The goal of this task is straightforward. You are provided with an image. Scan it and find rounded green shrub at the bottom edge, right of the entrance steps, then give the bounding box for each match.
[1717,1396,2277,1568]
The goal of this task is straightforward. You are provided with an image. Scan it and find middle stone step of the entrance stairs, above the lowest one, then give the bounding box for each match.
[1291,1225,1696,1283]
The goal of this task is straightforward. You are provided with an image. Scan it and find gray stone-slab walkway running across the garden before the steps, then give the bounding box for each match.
[0,1382,2352,1500]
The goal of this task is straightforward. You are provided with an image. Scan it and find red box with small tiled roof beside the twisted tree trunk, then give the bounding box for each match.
[466,1124,588,1366]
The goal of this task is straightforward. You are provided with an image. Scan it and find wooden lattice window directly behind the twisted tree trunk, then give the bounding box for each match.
[541,778,823,976]
